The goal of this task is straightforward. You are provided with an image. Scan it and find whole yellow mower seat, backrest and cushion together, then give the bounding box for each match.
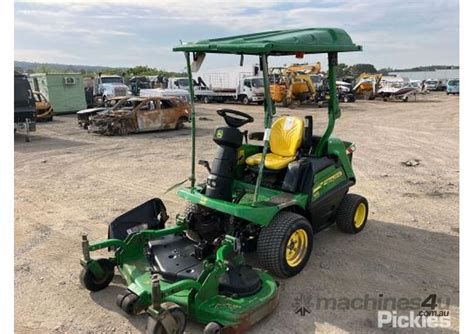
[245,116,304,170]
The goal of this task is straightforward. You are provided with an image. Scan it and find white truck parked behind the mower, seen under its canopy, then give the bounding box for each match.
[168,67,265,104]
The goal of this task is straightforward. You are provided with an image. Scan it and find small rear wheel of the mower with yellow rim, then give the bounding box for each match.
[336,194,369,234]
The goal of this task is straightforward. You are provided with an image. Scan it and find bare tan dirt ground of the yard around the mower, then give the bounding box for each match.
[15,93,459,333]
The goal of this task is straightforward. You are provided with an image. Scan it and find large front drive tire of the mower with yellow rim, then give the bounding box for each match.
[257,211,313,277]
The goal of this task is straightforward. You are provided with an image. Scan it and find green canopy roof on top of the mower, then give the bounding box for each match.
[173,28,362,55]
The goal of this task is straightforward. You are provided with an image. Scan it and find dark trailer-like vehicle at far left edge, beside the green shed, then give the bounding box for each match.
[14,74,36,142]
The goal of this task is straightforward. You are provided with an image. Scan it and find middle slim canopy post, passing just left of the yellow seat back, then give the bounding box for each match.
[252,55,273,205]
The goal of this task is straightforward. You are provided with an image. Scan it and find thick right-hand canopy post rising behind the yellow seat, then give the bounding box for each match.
[316,52,341,158]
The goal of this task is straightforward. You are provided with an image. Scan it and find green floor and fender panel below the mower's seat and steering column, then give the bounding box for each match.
[178,181,308,226]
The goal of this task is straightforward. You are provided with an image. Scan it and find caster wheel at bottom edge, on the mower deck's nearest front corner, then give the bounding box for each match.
[146,303,186,334]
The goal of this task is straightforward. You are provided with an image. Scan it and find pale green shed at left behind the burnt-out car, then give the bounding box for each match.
[29,73,87,114]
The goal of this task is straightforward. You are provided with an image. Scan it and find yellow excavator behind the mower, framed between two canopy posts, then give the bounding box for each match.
[270,62,321,106]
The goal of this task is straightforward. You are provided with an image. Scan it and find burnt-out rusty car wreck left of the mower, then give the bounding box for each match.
[88,96,191,136]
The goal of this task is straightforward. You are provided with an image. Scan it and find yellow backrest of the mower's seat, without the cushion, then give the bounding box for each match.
[270,116,304,157]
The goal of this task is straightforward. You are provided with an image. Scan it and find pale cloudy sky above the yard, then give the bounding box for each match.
[15,0,459,70]
